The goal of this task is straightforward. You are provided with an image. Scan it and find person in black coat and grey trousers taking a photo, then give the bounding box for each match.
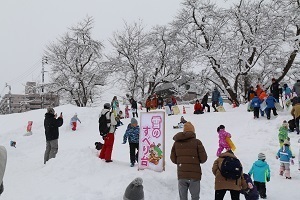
[44,107,63,164]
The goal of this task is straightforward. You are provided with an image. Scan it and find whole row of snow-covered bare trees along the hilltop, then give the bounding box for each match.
[46,0,300,106]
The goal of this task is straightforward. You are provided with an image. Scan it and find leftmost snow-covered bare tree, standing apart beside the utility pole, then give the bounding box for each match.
[45,17,106,107]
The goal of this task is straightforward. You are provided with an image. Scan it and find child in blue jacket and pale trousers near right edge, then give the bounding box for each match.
[276,140,292,179]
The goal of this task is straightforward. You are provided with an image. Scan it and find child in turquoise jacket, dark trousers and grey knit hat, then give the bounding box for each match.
[249,153,270,199]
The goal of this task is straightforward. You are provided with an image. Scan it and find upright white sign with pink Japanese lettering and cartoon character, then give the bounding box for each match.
[138,112,165,172]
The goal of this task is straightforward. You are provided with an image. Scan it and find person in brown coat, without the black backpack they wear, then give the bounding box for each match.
[212,150,247,200]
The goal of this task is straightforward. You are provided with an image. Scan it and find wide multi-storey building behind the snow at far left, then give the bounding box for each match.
[0,82,59,114]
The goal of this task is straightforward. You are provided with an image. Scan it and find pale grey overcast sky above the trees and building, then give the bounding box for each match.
[0,0,234,96]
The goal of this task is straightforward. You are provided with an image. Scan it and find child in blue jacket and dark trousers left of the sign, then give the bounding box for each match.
[122,118,140,167]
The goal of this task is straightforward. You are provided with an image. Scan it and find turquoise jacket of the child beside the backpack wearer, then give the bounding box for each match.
[249,160,270,183]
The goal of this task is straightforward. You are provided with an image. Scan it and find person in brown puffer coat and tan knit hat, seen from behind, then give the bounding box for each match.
[170,122,207,200]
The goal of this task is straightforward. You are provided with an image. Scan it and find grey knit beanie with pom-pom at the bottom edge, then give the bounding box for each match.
[123,177,144,200]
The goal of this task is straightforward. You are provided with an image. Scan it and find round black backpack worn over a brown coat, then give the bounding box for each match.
[220,156,243,180]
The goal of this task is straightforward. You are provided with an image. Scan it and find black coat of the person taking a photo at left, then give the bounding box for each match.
[44,113,63,141]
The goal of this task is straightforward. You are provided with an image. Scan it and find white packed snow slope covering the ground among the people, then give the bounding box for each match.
[0,104,300,200]
